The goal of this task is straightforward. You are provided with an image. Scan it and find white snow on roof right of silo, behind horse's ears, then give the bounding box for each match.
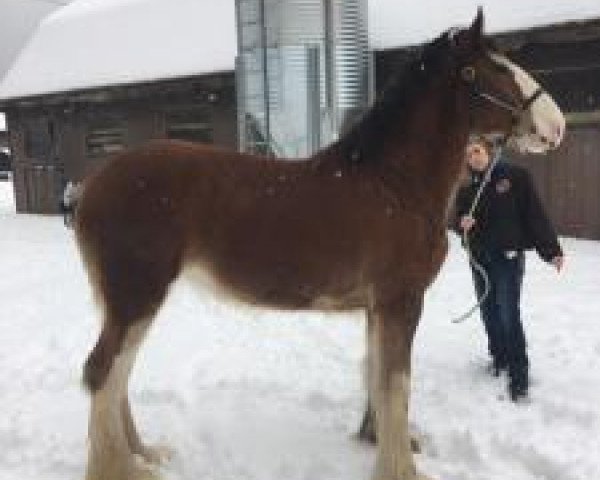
[369,0,600,50]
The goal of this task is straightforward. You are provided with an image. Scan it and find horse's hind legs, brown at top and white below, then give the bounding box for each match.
[84,251,178,480]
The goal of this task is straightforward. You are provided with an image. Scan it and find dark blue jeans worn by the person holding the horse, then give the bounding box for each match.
[471,252,529,387]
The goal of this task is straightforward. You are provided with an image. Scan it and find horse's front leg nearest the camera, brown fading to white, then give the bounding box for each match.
[369,293,424,480]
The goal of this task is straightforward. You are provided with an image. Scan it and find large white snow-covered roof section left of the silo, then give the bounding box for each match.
[0,0,237,99]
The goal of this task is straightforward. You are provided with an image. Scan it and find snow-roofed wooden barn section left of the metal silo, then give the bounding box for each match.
[0,0,237,213]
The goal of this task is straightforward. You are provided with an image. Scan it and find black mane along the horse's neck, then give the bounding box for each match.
[331,30,453,164]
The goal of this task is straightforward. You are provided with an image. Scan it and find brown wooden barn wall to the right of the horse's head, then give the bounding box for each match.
[511,34,600,240]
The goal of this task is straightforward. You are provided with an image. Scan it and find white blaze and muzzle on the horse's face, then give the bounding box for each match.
[490,53,566,153]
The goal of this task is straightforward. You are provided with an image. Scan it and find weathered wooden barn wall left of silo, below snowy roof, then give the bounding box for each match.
[7,74,237,213]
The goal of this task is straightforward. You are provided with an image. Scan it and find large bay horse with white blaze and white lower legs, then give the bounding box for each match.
[75,10,565,480]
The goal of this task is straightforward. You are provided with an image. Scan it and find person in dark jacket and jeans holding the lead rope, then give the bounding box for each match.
[454,137,564,401]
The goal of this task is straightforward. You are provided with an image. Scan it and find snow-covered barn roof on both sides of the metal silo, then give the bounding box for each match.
[0,0,600,100]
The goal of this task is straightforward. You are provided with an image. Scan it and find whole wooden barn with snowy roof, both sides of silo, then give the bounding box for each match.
[0,0,600,239]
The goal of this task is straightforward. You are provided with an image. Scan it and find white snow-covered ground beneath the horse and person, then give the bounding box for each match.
[0,183,600,480]
